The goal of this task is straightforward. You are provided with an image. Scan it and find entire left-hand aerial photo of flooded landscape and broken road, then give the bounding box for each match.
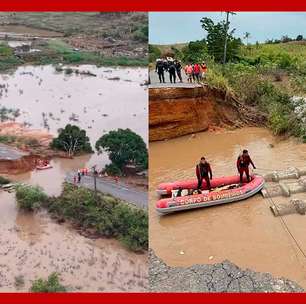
[0,13,148,291]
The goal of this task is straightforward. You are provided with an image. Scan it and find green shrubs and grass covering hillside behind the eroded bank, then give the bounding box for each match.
[149,20,306,142]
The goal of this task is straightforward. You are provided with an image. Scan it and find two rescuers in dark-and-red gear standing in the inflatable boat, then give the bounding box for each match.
[196,150,256,191]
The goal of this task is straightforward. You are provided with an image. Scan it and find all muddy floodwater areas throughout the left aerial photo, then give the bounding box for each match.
[0,66,148,291]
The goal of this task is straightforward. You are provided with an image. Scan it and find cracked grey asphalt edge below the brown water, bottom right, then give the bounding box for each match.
[149,250,304,292]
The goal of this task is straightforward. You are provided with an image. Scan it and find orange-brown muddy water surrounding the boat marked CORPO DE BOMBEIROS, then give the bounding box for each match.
[149,128,306,288]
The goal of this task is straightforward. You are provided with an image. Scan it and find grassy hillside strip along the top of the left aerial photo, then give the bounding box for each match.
[0,12,148,43]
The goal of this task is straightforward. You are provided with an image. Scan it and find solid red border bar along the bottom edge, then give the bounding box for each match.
[0,293,306,304]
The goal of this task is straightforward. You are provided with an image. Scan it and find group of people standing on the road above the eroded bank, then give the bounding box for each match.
[155,57,207,83]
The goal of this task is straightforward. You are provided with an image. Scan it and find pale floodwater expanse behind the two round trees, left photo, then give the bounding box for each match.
[0,65,148,168]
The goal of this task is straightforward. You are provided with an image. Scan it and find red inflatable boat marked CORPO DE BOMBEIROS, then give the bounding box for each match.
[156,175,265,214]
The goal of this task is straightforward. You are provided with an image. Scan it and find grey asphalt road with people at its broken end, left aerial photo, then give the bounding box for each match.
[66,172,148,209]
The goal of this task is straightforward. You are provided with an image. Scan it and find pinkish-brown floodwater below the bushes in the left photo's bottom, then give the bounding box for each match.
[0,192,147,291]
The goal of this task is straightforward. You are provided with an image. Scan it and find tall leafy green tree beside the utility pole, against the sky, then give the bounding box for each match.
[201,17,242,62]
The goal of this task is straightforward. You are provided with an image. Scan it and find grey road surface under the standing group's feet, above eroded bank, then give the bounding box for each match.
[149,70,202,89]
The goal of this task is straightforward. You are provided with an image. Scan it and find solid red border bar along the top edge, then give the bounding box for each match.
[0,0,306,12]
